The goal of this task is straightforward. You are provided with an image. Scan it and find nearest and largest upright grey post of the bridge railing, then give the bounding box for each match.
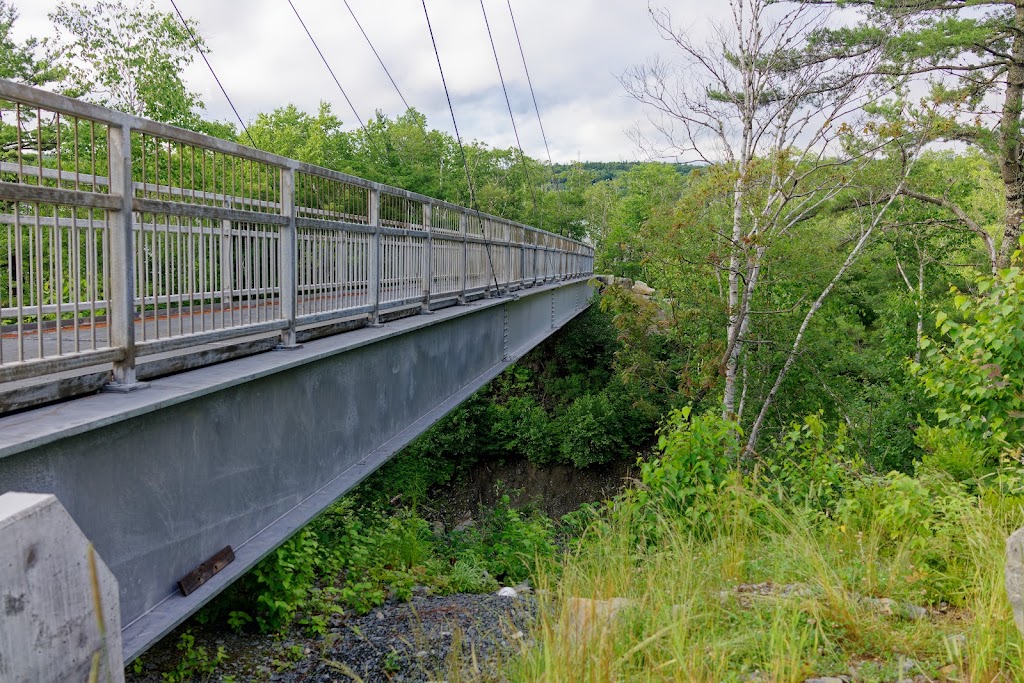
[105,124,146,391]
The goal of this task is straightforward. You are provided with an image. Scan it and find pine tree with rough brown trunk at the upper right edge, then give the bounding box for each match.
[799,0,1024,269]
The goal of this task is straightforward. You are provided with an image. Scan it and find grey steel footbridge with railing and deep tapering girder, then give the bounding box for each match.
[0,81,593,661]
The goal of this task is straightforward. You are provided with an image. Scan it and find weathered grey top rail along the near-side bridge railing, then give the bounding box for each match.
[0,79,589,249]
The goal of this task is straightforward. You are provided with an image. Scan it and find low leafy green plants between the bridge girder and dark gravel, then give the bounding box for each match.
[203,485,555,635]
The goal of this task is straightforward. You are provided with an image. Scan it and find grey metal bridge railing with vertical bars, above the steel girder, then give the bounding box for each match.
[0,80,593,386]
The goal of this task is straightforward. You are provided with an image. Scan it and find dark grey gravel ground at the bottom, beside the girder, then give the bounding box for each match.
[126,595,537,683]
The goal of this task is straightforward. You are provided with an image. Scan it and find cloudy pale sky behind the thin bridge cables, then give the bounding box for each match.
[13,0,725,163]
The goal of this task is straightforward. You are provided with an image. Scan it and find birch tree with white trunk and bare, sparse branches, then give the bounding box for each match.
[621,0,920,451]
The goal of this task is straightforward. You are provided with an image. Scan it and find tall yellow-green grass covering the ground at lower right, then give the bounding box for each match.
[497,479,1024,683]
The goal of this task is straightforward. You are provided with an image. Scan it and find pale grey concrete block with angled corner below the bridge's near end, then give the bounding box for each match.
[0,493,124,683]
